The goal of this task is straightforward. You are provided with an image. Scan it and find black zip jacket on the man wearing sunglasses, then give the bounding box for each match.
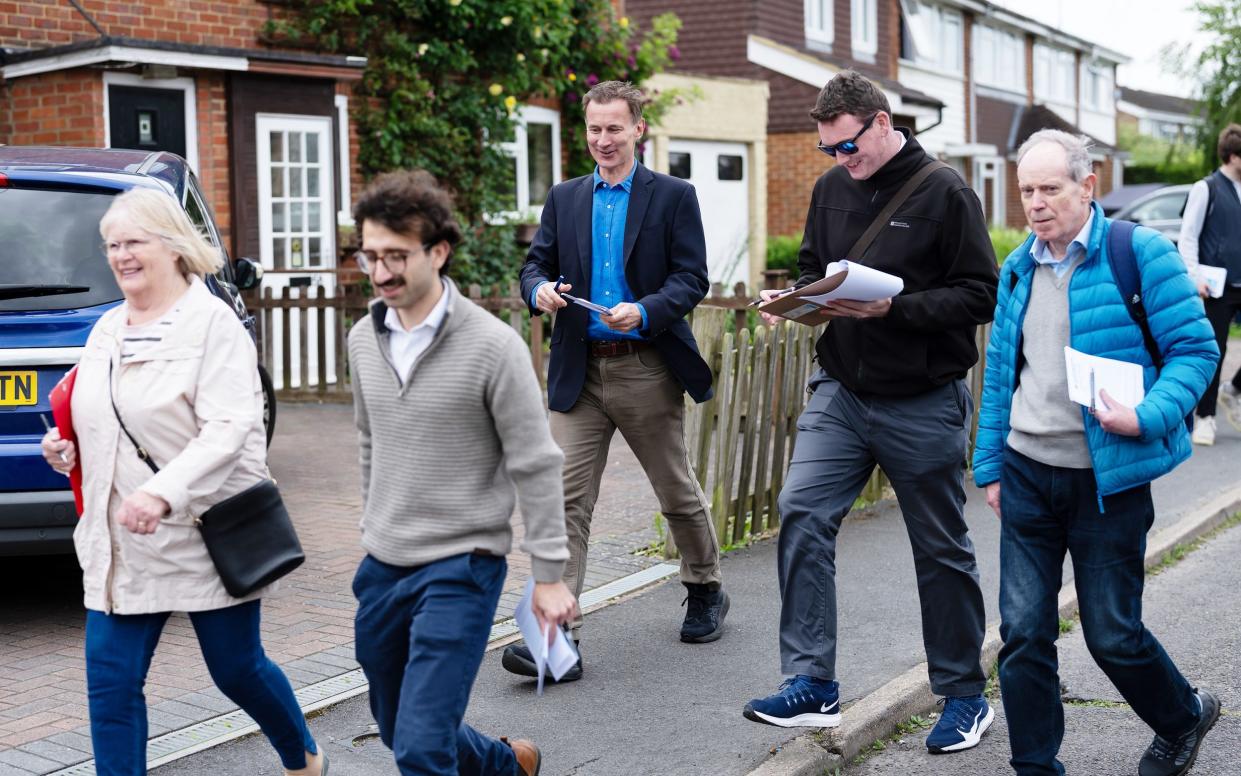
[797,129,998,396]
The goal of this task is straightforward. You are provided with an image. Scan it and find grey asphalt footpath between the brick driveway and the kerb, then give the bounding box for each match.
[147,402,1241,776]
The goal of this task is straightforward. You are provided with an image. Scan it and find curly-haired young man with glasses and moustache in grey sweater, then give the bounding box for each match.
[349,170,577,776]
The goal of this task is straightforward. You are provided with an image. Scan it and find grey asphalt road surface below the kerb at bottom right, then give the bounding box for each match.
[845,514,1241,776]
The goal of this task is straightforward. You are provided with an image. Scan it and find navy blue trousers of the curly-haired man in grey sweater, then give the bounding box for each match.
[354,555,517,776]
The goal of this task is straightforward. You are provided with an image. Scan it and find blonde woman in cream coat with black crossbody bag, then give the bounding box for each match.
[42,190,328,776]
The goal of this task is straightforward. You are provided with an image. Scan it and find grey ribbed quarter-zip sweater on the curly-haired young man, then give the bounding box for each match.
[349,282,568,582]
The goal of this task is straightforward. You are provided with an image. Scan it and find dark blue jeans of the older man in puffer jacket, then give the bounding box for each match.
[999,448,1199,775]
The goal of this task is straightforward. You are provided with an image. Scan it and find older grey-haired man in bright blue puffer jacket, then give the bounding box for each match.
[974,129,1220,776]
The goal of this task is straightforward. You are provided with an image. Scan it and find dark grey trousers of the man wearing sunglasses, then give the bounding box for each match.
[778,370,987,695]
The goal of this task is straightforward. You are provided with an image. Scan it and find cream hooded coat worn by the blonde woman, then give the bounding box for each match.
[72,278,268,615]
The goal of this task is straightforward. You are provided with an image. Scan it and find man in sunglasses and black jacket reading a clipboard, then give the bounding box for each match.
[743,71,997,752]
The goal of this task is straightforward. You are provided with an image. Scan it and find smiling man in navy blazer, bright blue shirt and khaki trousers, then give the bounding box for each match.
[503,81,728,682]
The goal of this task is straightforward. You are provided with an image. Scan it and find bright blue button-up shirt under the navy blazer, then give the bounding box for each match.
[530,161,647,340]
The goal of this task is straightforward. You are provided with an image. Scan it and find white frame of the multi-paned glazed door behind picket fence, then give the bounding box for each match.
[254,113,336,271]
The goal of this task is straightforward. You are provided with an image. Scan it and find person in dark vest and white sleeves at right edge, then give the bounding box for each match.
[1176,124,1241,444]
